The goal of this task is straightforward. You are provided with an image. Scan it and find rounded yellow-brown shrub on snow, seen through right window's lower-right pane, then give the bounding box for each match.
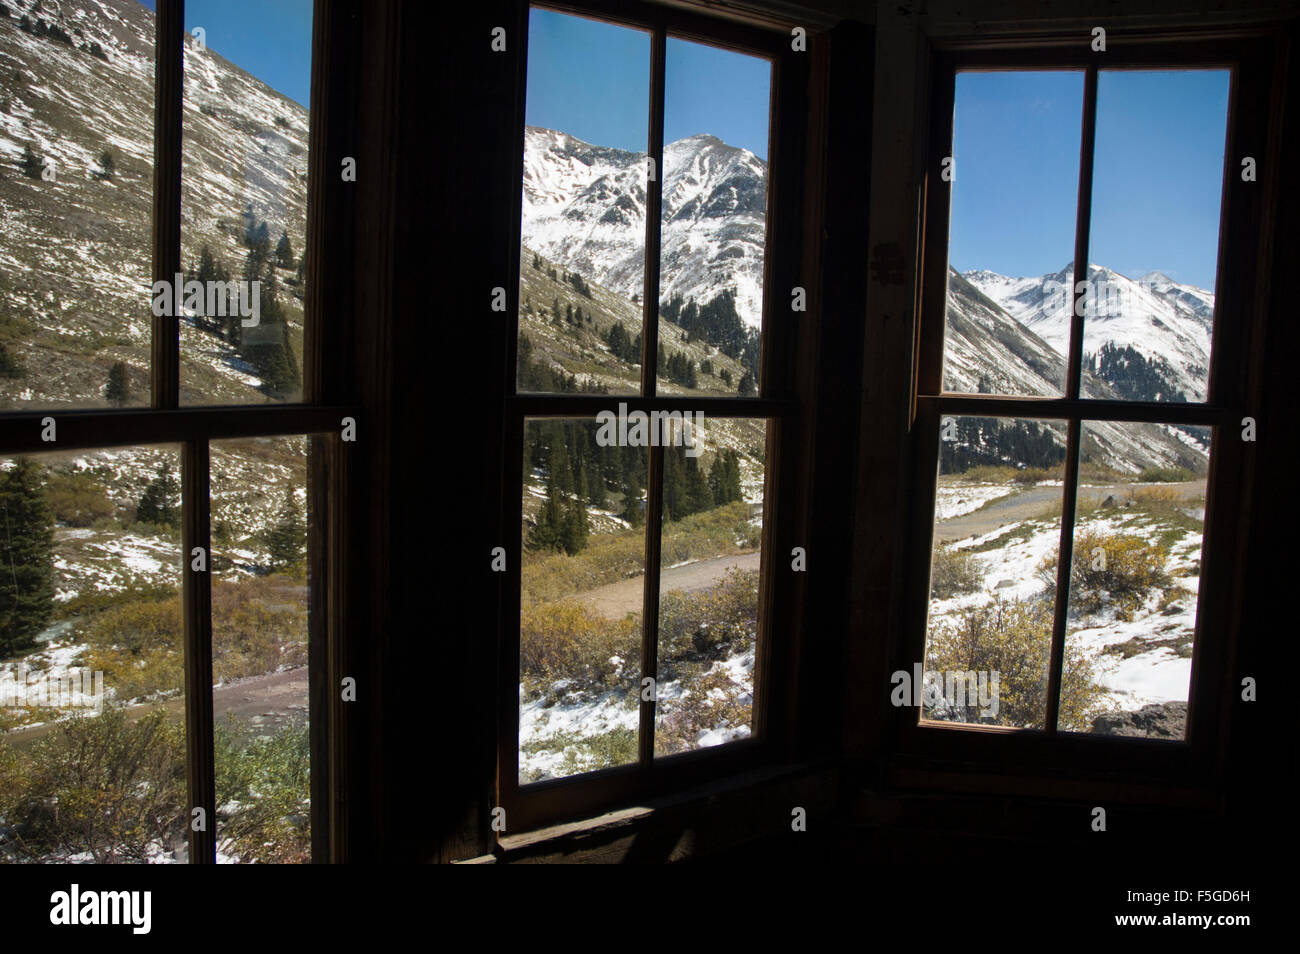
[1039,529,1173,620]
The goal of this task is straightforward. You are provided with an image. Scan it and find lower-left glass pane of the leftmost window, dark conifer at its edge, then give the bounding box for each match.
[0,447,190,863]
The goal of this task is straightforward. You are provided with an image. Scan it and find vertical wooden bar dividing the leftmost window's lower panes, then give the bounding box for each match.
[181,441,217,864]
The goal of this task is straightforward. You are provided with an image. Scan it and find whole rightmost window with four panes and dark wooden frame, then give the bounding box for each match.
[894,44,1262,769]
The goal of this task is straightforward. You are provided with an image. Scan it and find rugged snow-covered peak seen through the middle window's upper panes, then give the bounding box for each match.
[523,126,767,328]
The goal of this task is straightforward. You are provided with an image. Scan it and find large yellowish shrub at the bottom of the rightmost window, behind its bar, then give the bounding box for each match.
[914,598,1108,732]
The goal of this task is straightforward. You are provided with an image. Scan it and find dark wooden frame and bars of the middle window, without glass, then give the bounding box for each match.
[497,0,807,833]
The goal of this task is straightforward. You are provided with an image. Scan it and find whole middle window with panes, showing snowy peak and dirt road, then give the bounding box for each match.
[498,6,797,831]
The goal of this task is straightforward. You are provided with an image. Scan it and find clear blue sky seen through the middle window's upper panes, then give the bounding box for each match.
[525,9,772,159]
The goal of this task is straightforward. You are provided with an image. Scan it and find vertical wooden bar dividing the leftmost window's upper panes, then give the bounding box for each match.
[150,0,185,409]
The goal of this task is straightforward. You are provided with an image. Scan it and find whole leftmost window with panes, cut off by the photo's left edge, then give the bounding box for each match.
[0,0,359,863]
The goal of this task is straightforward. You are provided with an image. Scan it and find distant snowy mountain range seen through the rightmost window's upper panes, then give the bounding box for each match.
[963,265,1214,400]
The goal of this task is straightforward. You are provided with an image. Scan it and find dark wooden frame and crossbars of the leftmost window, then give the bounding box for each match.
[0,0,365,864]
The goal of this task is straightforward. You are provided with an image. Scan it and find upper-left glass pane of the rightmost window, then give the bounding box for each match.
[943,71,1083,395]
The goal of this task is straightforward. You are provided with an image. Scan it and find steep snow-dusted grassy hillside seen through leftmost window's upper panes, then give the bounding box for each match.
[0,0,308,409]
